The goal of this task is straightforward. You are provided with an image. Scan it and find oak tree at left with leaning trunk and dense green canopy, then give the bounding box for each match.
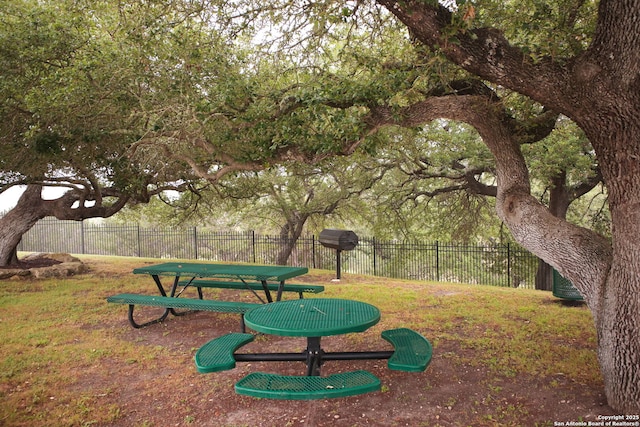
[0,0,234,266]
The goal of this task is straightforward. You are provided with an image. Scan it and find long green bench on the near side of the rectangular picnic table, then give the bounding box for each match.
[107,294,262,332]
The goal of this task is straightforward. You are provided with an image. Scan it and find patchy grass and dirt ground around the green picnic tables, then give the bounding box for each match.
[0,256,612,427]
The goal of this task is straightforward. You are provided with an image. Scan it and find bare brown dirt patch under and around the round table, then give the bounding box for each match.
[92,292,614,427]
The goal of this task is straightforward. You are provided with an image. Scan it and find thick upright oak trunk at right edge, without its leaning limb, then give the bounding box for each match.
[584,118,640,414]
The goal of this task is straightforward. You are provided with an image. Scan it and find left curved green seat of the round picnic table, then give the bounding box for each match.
[195,333,254,374]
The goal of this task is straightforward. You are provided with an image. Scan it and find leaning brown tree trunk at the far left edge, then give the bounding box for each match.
[0,185,45,267]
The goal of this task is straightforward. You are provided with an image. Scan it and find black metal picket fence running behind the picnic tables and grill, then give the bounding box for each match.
[18,218,538,289]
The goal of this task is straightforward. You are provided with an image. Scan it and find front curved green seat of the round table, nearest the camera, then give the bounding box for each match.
[235,371,380,400]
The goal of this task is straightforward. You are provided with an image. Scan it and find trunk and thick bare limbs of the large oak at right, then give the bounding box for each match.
[360,0,640,413]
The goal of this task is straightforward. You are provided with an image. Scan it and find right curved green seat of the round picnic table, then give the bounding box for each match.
[382,328,433,372]
